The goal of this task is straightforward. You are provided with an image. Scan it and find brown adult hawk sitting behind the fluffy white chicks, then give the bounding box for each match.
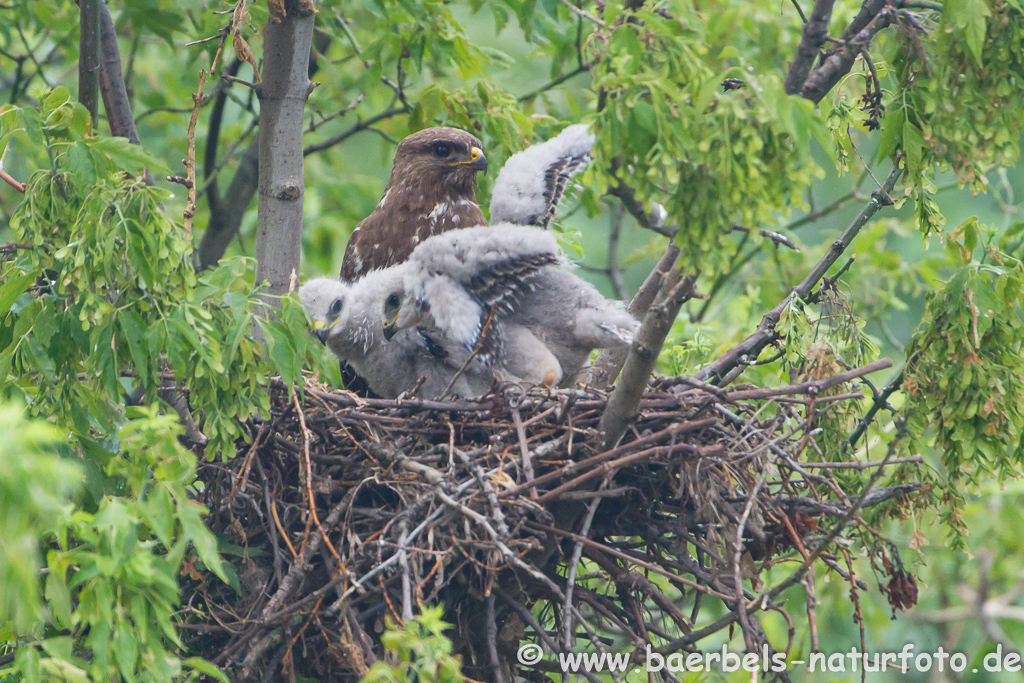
[341,128,487,281]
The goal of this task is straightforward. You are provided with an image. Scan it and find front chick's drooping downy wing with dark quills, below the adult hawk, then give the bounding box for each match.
[403,224,561,357]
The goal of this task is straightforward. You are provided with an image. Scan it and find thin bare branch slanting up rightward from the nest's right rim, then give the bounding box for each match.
[695,156,903,382]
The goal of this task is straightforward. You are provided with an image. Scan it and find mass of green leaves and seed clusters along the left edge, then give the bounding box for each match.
[0,88,317,681]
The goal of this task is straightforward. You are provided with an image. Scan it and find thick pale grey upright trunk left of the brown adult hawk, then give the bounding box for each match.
[254,0,316,338]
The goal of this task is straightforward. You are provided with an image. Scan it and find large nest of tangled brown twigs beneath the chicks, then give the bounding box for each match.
[185,364,915,682]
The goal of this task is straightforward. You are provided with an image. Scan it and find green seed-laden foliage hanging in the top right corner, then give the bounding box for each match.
[879,0,1024,236]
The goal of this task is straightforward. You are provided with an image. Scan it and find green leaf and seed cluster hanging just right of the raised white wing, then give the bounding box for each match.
[594,6,823,267]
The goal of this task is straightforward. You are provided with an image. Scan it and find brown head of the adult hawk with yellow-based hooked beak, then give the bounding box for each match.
[389,128,487,193]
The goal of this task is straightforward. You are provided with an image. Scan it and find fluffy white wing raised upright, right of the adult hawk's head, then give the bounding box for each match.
[490,124,594,228]
